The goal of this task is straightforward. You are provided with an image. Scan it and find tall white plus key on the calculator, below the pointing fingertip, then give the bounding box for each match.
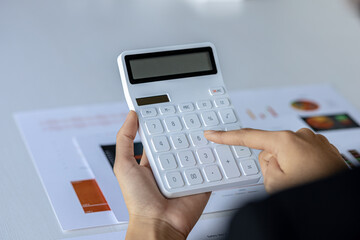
[215,145,240,178]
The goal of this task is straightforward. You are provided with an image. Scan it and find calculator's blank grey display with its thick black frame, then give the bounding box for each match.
[125,47,217,84]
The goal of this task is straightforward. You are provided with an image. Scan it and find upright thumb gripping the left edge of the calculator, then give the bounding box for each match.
[114,111,138,169]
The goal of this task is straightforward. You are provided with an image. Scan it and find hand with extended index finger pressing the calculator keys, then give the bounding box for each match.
[205,128,347,193]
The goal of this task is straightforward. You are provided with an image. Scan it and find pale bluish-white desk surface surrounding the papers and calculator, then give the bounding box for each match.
[0,0,360,239]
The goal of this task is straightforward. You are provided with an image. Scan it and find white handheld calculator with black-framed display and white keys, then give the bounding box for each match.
[118,43,261,198]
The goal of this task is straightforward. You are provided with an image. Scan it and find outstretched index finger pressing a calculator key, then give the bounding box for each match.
[204,128,281,152]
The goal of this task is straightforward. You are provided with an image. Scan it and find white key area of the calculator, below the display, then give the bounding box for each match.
[140,87,259,192]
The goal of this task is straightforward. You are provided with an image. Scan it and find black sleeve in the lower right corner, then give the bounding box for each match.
[228,169,360,240]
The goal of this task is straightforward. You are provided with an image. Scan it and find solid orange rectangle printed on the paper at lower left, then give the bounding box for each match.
[71,179,111,213]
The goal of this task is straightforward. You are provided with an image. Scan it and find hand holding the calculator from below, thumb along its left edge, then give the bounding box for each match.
[114,111,210,239]
